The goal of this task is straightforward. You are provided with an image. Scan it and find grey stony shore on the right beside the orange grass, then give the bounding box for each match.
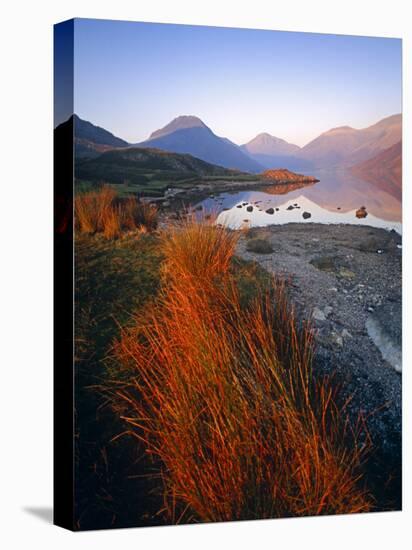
[238,224,402,507]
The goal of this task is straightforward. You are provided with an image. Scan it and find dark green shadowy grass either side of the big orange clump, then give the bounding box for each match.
[75,225,276,529]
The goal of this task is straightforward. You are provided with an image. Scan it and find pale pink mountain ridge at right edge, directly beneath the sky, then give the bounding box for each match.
[299,114,402,168]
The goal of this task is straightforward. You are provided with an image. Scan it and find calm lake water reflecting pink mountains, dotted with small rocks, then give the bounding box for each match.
[198,171,402,234]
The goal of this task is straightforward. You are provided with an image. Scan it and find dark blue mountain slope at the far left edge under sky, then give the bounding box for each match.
[72,115,129,157]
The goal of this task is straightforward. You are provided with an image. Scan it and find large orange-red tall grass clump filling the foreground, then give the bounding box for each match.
[111,219,371,522]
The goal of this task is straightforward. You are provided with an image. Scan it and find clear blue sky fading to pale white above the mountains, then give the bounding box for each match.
[66,19,402,146]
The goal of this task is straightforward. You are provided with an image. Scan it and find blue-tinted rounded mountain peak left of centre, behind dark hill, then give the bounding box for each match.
[136,116,262,173]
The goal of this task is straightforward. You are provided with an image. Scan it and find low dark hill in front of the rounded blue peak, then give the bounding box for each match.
[75,147,243,188]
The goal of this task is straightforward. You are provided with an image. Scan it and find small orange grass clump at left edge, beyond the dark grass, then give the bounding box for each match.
[74,186,157,239]
